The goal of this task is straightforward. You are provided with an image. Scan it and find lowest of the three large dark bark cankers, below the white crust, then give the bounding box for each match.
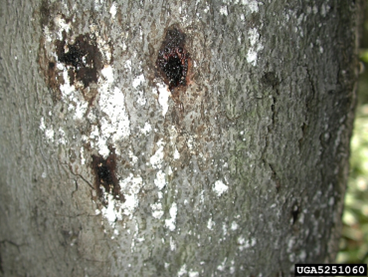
[92,152,125,204]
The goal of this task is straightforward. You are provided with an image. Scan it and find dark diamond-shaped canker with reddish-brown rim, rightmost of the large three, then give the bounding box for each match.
[156,27,189,91]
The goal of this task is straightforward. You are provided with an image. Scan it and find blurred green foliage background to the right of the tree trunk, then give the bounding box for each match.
[337,0,368,264]
